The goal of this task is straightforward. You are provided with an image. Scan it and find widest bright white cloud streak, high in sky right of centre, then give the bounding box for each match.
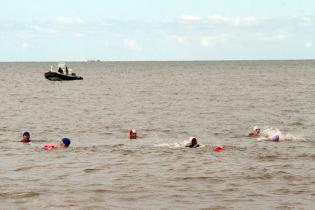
[208,15,257,27]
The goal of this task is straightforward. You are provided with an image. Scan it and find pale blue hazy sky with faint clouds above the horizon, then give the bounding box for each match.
[0,0,315,61]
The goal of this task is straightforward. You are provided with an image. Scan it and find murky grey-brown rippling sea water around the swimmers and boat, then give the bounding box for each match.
[0,60,315,209]
